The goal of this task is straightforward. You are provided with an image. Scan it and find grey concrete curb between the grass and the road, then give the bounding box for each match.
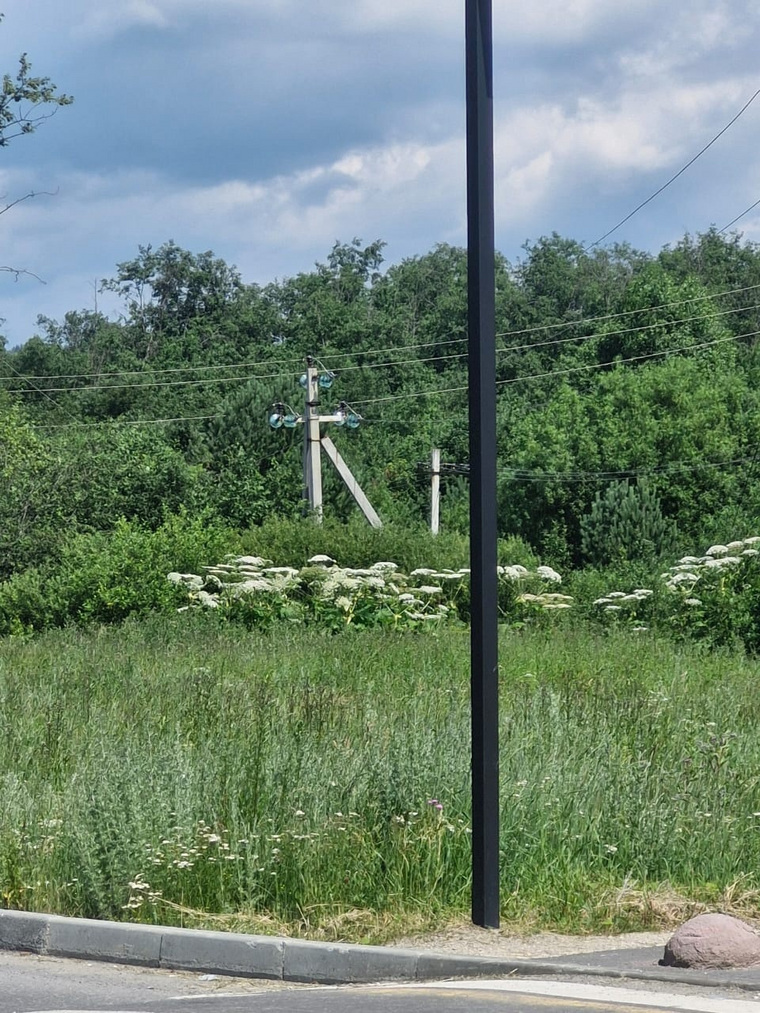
[0,911,758,992]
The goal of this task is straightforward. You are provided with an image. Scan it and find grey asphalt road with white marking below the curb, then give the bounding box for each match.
[0,952,760,1013]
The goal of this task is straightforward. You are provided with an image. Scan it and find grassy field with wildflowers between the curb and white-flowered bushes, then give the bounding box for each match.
[0,616,760,941]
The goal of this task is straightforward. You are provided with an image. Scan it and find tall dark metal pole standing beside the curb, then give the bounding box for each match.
[465,0,499,929]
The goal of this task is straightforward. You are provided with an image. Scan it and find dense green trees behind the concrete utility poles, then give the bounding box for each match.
[0,231,760,632]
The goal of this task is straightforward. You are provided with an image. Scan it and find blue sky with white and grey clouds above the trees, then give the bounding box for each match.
[0,0,760,345]
